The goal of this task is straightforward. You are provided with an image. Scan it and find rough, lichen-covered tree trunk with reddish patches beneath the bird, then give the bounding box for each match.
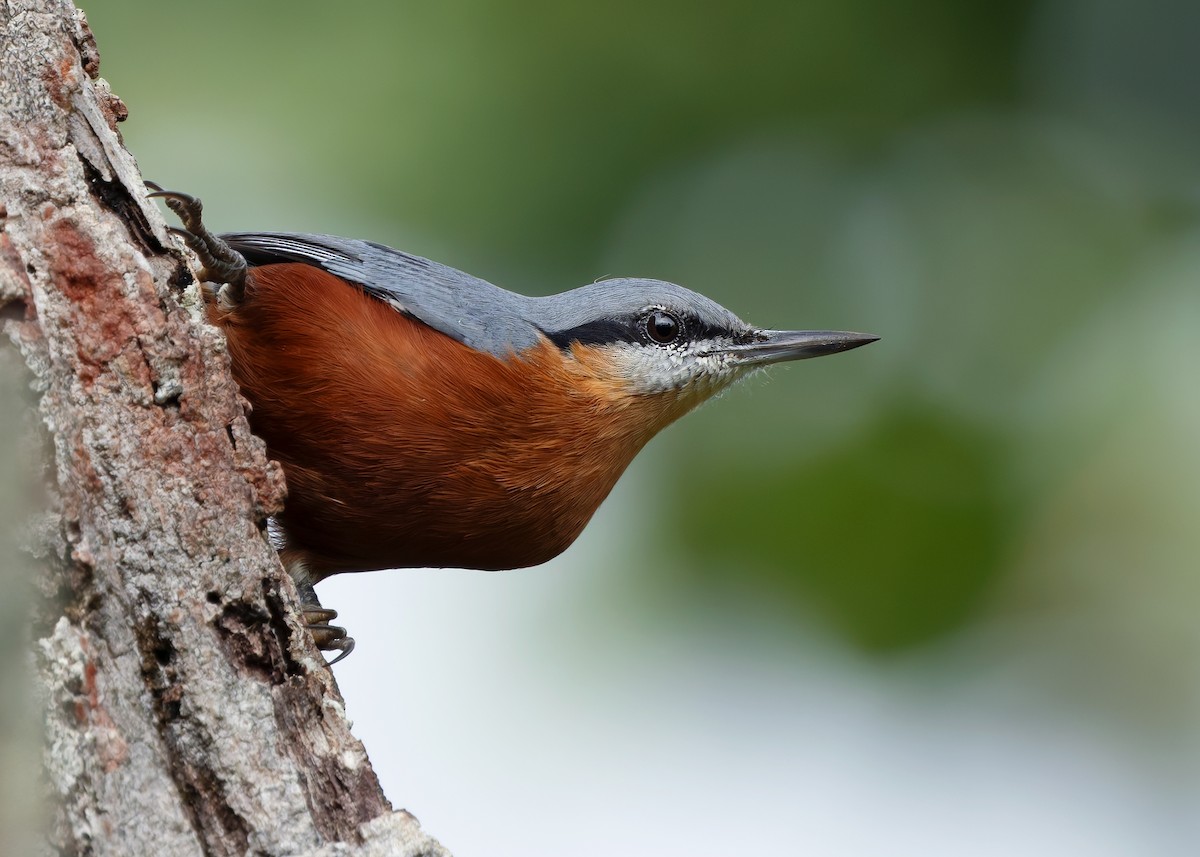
[0,0,446,857]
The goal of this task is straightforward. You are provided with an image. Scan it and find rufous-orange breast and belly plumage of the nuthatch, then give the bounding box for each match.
[209,264,673,580]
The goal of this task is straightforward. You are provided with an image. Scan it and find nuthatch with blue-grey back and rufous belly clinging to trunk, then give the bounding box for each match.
[151,185,877,657]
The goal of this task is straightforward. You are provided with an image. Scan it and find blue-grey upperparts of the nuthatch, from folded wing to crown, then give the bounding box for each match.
[221,232,751,356]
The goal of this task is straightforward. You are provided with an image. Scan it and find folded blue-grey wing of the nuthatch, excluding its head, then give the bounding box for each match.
[221,232,538,356]
